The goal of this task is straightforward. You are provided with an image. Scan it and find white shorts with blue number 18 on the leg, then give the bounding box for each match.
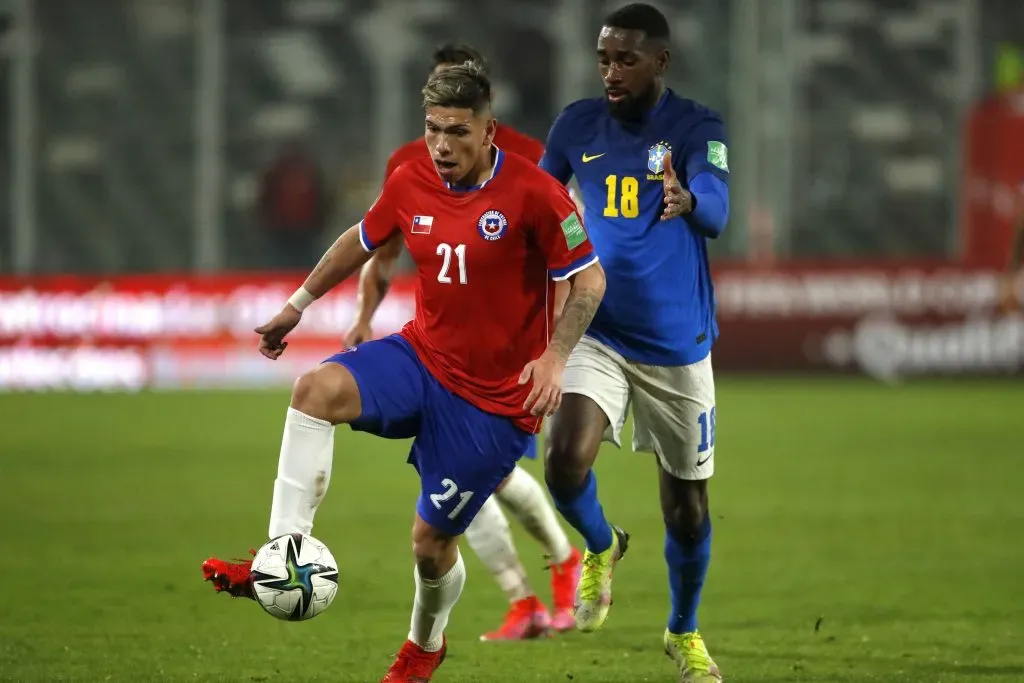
[562,337,715,479]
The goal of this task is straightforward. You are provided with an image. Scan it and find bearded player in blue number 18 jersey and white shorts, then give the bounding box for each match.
[541,3,729,681]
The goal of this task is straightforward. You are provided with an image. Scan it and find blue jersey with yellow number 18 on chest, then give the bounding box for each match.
[541,90,729,366]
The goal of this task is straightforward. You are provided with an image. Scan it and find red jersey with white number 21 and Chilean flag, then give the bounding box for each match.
[359,150,597,431]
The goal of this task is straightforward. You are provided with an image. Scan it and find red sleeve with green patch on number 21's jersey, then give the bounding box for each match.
[534,179,597,280]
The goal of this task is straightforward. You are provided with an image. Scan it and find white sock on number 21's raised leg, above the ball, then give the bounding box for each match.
[268,408,334,539]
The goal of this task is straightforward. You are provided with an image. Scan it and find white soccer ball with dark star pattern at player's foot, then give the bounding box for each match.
[251,533,338,622]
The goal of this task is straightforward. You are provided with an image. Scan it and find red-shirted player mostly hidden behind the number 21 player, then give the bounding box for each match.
[345,45,581,641]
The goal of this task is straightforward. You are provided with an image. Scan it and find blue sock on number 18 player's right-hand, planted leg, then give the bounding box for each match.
[665,514,711,634]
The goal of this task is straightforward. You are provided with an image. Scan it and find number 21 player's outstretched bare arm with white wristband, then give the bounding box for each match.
[255,225,370,360]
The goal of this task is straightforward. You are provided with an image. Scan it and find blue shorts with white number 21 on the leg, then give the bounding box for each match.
[325,335,534,536]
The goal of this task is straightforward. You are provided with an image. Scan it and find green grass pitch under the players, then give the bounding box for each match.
[0,379,1024,683]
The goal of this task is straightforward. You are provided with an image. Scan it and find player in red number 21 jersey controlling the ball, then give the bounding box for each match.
[203,65,604,683]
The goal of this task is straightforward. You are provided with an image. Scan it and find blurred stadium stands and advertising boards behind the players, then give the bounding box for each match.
[0,0,1024,387]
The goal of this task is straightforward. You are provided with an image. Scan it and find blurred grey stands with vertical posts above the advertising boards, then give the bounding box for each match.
[0,0,1024,272]
